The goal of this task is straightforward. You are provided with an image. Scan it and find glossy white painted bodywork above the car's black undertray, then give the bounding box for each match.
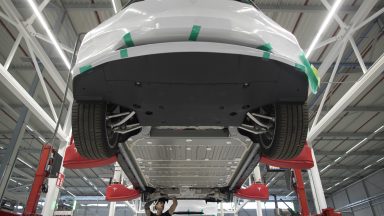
[74,0,303,75]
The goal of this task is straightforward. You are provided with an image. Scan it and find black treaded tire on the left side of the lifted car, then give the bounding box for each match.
[72,102,119,159]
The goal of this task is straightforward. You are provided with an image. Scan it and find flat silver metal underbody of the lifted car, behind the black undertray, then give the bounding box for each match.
[119,127,259,201]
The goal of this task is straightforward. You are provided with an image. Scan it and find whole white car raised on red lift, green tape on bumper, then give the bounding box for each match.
[72,0,318,200]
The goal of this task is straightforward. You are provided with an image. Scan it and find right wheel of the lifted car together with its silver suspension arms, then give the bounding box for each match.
[242,103,308,159]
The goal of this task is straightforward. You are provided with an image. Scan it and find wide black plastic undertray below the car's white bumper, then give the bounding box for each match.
[73,52,308,126]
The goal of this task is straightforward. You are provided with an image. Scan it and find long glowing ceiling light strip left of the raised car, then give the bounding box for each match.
[27,0,71,70]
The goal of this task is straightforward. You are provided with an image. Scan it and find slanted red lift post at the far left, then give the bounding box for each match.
[23,144,53,216]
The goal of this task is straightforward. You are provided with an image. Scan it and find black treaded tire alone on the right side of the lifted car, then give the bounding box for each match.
[258,103,308,159]
